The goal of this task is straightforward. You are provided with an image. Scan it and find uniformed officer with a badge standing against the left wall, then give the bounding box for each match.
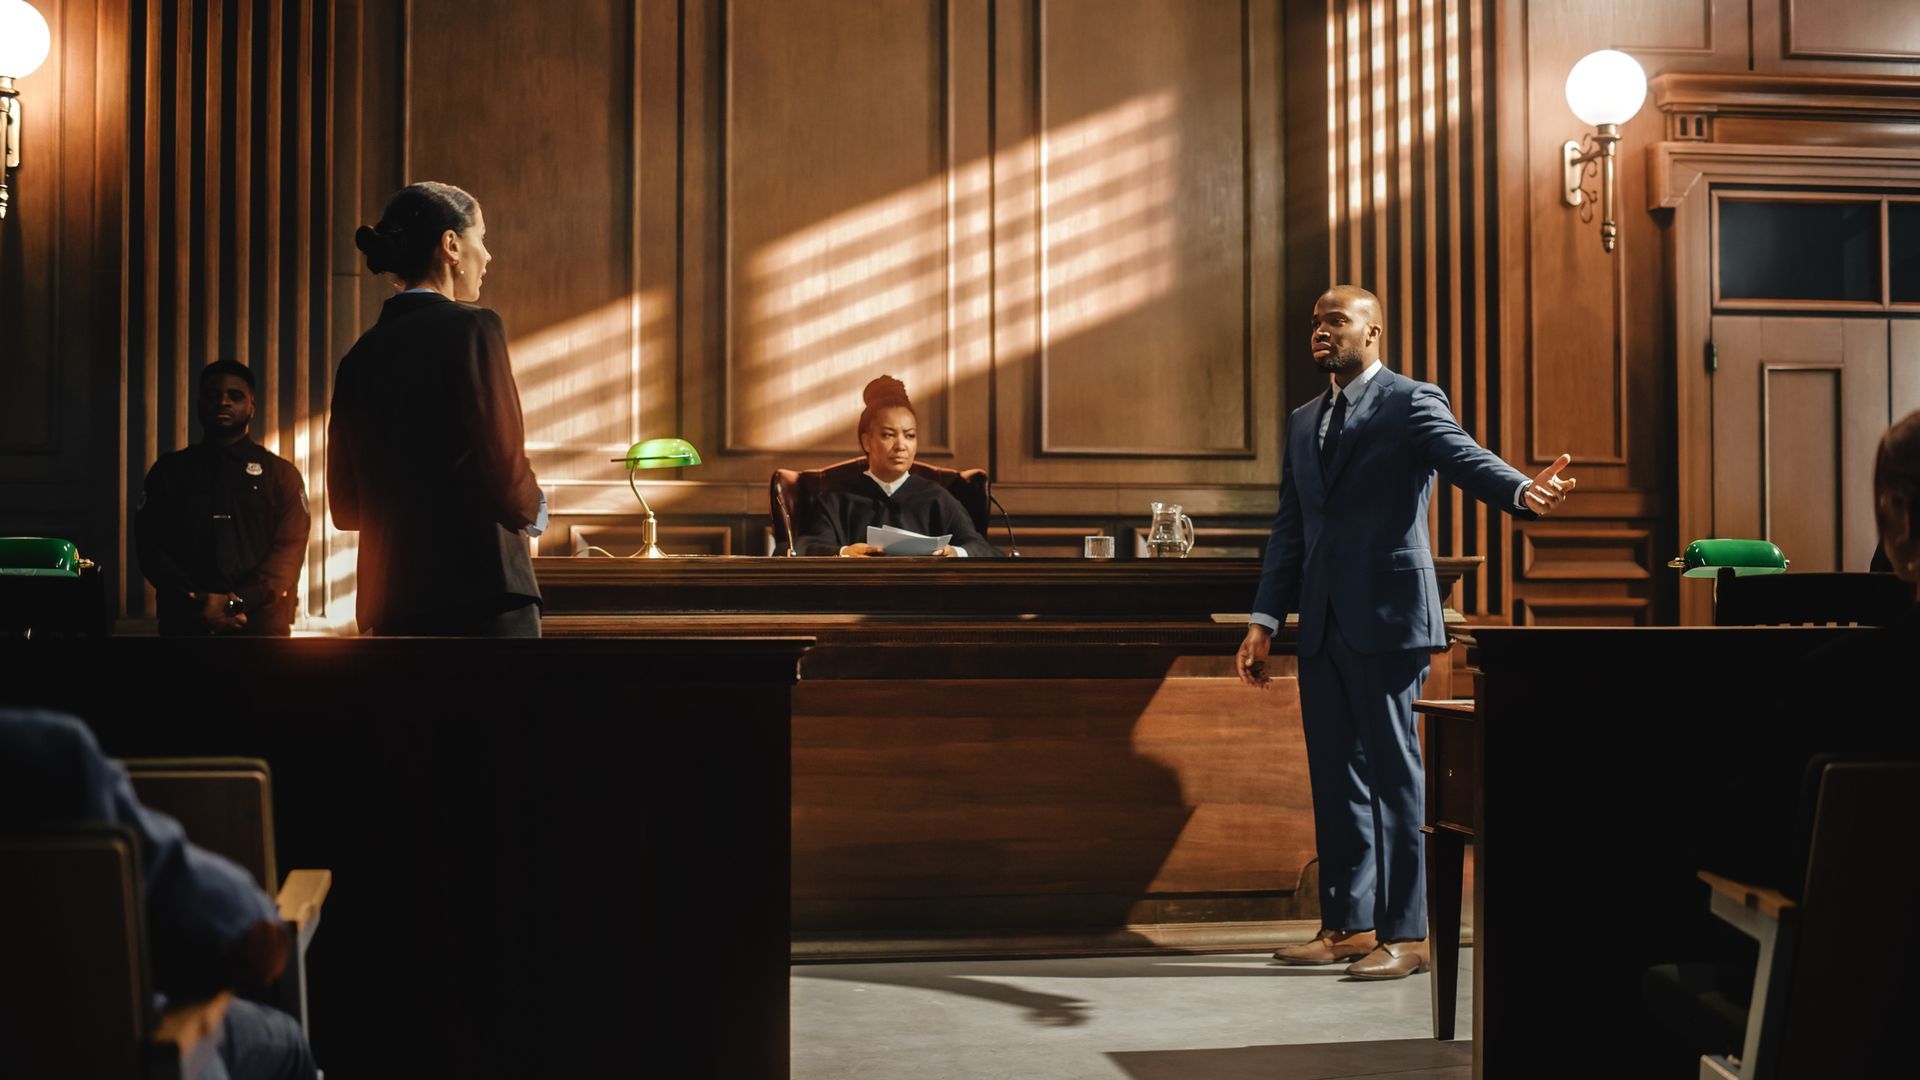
[134,359,311,636]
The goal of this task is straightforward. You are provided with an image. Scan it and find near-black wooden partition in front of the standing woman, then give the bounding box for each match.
[0,638,806,1080]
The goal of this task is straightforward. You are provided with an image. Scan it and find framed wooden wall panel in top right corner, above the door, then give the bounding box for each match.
[1751,0,1920,75]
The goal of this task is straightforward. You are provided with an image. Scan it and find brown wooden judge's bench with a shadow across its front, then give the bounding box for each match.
[534,557,1475,955]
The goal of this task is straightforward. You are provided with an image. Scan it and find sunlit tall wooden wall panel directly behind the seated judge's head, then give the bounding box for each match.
[664,0,991,515]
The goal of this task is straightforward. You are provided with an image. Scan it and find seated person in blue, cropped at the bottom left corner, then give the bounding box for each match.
[0,709,317,1080]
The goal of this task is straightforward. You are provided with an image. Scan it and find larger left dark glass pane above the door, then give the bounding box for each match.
[1720,200,1880,304]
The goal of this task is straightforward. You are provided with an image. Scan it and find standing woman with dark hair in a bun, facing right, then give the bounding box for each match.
[326,183,541,638]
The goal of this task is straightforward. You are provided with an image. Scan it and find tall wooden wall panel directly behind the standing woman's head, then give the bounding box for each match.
[405,0,637,482]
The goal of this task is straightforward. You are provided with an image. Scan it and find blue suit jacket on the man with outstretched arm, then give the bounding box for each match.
[1254,369,1534,655]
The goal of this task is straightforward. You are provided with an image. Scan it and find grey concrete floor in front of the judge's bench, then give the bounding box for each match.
[793,949,1473,1080]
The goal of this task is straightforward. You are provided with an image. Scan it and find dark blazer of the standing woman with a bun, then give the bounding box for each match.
[326,292,540,630]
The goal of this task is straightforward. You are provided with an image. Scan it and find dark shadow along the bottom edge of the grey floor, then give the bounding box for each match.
[1106,1040,1473,1080]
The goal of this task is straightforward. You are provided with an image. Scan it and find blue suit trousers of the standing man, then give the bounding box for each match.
[1300,615,1430,942]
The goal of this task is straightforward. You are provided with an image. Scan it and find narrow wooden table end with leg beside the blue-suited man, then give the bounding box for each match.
[1413,698,1475,1040]
